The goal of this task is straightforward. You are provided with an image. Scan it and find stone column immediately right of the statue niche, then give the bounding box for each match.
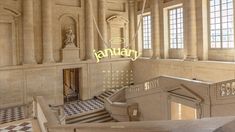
[85,0,94,60]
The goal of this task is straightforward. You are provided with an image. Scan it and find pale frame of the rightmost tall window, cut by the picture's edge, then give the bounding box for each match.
[207,0,235,50]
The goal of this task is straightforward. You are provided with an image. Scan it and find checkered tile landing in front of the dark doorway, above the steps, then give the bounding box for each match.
[64,99,104,116]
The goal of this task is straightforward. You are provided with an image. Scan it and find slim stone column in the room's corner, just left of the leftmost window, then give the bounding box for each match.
[129,0,136,49]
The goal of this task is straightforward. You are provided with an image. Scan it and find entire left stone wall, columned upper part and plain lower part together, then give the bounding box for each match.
[0,0,133,108]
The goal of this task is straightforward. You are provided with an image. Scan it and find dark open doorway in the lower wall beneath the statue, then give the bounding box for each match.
[63,68,80,103]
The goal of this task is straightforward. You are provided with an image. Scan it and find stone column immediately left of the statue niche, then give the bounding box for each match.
[42,0,54,63]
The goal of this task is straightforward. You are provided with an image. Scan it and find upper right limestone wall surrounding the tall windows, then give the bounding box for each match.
[135,0,235,61]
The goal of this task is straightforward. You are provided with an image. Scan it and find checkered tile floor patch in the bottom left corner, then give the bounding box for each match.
[0,122,33,132]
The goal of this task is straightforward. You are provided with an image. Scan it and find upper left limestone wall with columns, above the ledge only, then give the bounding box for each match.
[0,0,131,66]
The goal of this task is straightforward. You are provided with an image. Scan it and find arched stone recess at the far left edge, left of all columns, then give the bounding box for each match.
[0,6,21,66]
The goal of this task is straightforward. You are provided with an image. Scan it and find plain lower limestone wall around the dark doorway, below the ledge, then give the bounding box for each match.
[0,59,130,108]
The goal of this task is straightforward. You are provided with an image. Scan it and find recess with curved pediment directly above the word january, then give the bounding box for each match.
[107,15,129,54]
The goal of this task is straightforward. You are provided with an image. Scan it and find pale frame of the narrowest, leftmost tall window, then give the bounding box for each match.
[141,12,153,50]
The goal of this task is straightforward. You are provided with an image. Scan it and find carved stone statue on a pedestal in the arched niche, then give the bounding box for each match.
[64,27,76,48]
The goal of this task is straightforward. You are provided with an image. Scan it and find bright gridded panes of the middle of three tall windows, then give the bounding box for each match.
[168,7,184,49]
